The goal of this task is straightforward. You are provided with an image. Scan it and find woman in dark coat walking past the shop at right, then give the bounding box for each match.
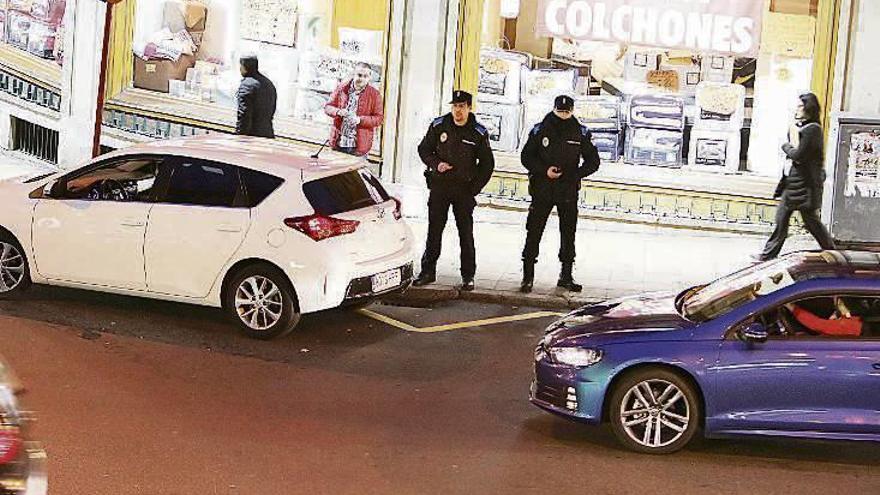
[753,93,835,261]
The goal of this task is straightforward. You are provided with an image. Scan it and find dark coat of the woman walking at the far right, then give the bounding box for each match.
[774,122,825,210]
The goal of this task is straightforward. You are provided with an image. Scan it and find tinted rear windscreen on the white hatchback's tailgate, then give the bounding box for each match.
[303,169,390,215]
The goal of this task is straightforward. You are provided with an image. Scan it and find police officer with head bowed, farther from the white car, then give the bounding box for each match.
[520,95,599,292]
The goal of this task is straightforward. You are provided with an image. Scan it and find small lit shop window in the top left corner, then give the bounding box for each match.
[0,0,66,65]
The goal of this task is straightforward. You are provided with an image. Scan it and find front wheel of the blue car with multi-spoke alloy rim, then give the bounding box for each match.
[609,367,702,454]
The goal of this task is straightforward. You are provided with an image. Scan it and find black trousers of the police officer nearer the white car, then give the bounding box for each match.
[422,186,477,279]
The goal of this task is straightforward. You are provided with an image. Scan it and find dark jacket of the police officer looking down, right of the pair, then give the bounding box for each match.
[520,112,599,201]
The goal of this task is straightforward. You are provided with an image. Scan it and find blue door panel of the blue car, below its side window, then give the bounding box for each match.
[706,337,880,433]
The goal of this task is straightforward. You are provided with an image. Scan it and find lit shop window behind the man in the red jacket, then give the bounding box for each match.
[126,0,390,154]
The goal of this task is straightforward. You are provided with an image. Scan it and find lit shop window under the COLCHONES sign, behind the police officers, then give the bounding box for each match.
[474,0,824,181]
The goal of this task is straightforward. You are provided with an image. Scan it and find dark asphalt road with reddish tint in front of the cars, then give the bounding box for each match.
[0,288,880,495]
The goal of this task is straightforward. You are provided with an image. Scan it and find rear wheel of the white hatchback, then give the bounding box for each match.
[224,265,300,340]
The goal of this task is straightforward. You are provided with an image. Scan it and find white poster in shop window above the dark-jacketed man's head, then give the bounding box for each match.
[240,0,297,46]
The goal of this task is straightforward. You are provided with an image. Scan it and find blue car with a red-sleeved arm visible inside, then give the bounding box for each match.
[530,251,880,454]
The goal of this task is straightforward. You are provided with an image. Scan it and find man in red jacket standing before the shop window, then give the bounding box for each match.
[324,62,385,156]
